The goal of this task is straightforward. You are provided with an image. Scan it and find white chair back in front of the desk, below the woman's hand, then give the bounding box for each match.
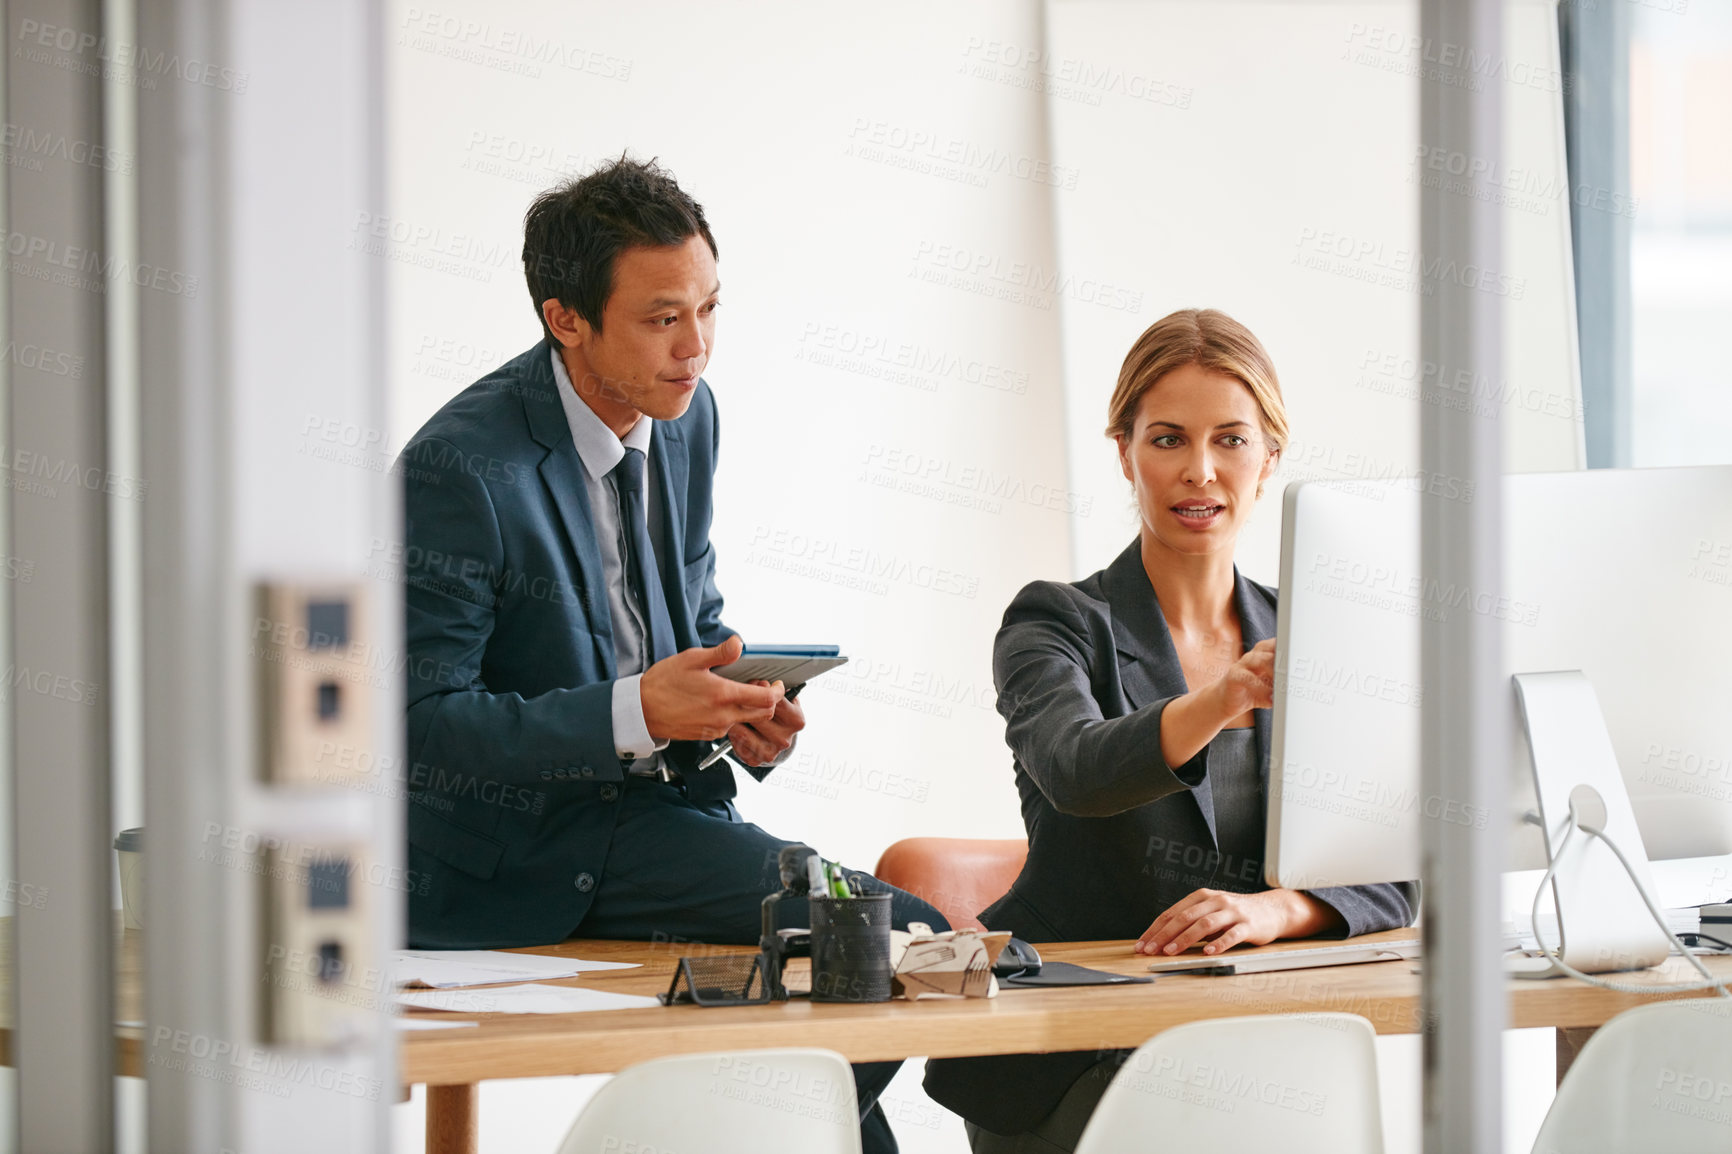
[1076,1014,1384,1154]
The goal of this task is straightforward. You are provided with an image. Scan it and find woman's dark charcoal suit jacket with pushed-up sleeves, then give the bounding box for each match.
[927,541,1417,1135]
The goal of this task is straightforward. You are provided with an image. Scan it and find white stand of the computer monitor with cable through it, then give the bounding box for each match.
[1505,669,1671,977]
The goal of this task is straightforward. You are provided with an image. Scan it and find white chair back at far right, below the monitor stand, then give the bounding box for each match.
[1533,998,1732,1154]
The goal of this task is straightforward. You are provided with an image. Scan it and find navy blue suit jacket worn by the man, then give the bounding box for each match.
[398,341,751,948]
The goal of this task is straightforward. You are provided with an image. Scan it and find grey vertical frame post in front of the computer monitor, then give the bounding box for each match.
[1417,0,1512,1154]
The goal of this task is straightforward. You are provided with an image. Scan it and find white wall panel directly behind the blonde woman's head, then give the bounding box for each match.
[1020,0,1581,584]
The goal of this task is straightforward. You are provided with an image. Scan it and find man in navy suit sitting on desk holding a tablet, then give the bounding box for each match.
[398,159,946,1151]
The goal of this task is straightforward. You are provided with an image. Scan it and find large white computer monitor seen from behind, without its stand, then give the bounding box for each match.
[1266,466,1732,887]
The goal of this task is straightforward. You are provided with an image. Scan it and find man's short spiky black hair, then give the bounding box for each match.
[523,156,719,340]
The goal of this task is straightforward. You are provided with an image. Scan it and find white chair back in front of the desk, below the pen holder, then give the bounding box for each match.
[559,1050,861,1154]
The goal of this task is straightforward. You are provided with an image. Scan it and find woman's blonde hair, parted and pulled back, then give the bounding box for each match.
[1107,308,1287,452]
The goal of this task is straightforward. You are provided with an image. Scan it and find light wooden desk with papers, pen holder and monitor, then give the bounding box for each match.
[402,930,1732,1154]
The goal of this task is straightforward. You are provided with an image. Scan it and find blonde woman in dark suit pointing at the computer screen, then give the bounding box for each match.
[927,308,1417,1154]
